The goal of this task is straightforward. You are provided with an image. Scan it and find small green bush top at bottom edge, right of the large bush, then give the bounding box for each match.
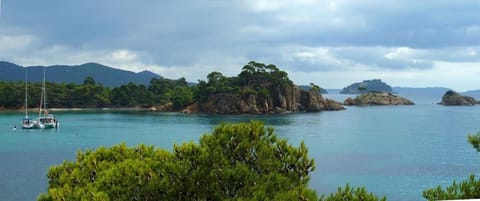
[320,184,387,201]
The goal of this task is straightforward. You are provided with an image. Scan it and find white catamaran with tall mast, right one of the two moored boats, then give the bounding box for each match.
[35,67,59,128]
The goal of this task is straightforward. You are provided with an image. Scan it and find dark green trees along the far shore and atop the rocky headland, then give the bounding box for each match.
[0,61,338,112]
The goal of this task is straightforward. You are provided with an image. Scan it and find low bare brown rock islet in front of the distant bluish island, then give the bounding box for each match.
[343,92,415,105]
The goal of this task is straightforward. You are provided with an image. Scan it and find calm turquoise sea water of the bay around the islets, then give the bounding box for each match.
[0,95,480,200]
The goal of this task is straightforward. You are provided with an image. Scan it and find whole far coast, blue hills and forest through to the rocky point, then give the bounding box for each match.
[0,61,344,114]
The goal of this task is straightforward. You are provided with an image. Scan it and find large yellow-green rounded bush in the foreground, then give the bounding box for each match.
[38,122,318,201]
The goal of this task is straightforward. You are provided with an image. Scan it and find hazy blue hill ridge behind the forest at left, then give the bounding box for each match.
[0,61,161,87]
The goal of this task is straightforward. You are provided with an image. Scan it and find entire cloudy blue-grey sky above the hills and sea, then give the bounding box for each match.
[0,0,480,91]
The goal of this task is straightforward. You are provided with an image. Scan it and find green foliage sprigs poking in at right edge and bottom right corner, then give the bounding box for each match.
[423,132,480,200]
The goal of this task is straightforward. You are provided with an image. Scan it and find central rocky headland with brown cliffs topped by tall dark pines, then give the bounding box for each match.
[184,61,344,114]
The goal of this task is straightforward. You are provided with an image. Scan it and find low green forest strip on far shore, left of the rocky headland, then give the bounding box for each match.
[0,77,195,109]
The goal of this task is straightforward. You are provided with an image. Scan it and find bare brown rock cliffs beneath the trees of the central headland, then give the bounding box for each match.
[190,86,345,114]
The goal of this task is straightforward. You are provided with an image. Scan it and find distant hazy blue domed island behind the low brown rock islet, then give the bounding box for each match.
[340,79,392,94]
